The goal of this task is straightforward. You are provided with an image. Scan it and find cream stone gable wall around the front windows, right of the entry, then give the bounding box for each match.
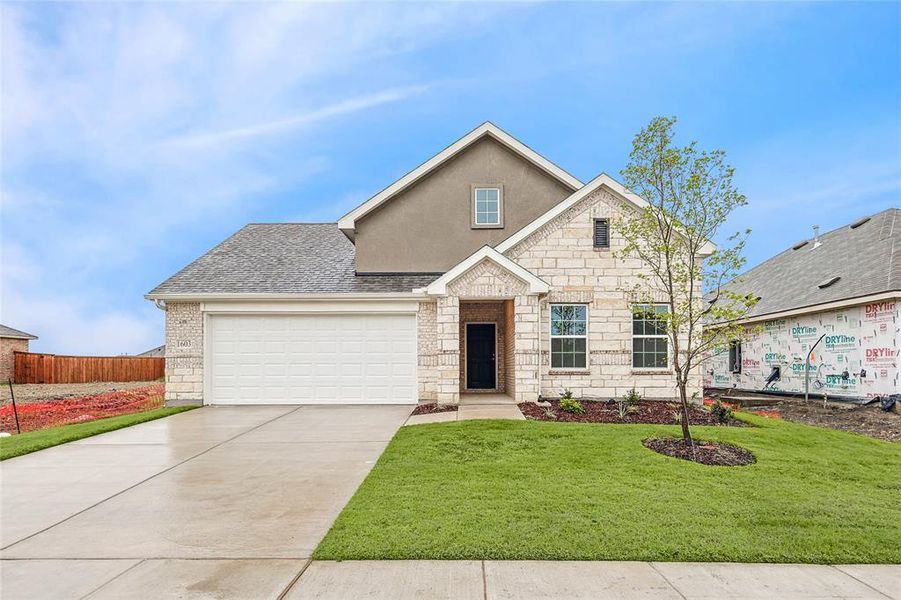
[506,190,702,399]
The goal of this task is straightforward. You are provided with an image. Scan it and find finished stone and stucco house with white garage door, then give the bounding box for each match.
[146,123,701,404]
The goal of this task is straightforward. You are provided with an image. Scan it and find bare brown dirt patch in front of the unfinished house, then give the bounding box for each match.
[709,392,901,442]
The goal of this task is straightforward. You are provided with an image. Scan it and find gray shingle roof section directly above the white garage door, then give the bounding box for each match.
[148,223,438,297]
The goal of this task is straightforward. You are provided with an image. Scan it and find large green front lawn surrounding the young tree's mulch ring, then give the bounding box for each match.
[314,416,901,563]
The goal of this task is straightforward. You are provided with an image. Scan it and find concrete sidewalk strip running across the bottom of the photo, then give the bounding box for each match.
[0,558,901,600]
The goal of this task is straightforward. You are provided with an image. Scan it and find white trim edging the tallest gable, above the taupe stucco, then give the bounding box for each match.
[338,122,582,239]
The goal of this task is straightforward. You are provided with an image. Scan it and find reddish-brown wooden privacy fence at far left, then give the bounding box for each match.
[14,352,166,383]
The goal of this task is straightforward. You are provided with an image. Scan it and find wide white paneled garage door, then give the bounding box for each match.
[208,315,416,404]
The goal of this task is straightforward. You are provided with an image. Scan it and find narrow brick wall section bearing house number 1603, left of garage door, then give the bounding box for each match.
[166,302,203,406]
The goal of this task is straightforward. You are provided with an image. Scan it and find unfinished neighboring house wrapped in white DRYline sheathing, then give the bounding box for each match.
[704,208,901,399]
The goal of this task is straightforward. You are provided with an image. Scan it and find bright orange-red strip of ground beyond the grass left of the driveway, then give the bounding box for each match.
[0,384,166,433]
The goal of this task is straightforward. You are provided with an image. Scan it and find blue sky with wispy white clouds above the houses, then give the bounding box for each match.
[0,3,901,354]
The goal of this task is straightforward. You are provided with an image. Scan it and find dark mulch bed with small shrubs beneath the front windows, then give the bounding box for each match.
[519,400,747,427]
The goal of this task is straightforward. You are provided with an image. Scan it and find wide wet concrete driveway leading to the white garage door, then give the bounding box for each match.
[0,406,410,600]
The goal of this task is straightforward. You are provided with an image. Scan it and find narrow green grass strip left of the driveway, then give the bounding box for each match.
[0,406,196,460]
